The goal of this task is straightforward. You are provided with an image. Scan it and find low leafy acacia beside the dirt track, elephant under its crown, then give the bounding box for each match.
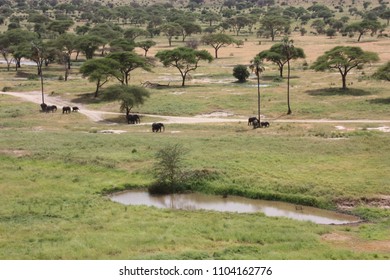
[102,84,150,118]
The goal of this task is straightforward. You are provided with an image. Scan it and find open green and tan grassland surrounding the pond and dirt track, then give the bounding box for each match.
[0,0,390,259]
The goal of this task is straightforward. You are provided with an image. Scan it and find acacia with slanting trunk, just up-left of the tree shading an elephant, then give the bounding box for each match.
[80,57,121,98]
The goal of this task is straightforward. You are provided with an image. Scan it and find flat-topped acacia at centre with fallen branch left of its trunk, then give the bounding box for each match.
[156,47,213,87]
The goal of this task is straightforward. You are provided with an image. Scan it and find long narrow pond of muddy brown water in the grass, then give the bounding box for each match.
[110,190,359,224]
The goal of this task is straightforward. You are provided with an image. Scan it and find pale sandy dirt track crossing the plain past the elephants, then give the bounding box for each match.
[0,91,390,124]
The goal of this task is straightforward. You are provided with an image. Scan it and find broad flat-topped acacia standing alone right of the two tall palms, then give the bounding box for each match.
[311,46,379,90]
